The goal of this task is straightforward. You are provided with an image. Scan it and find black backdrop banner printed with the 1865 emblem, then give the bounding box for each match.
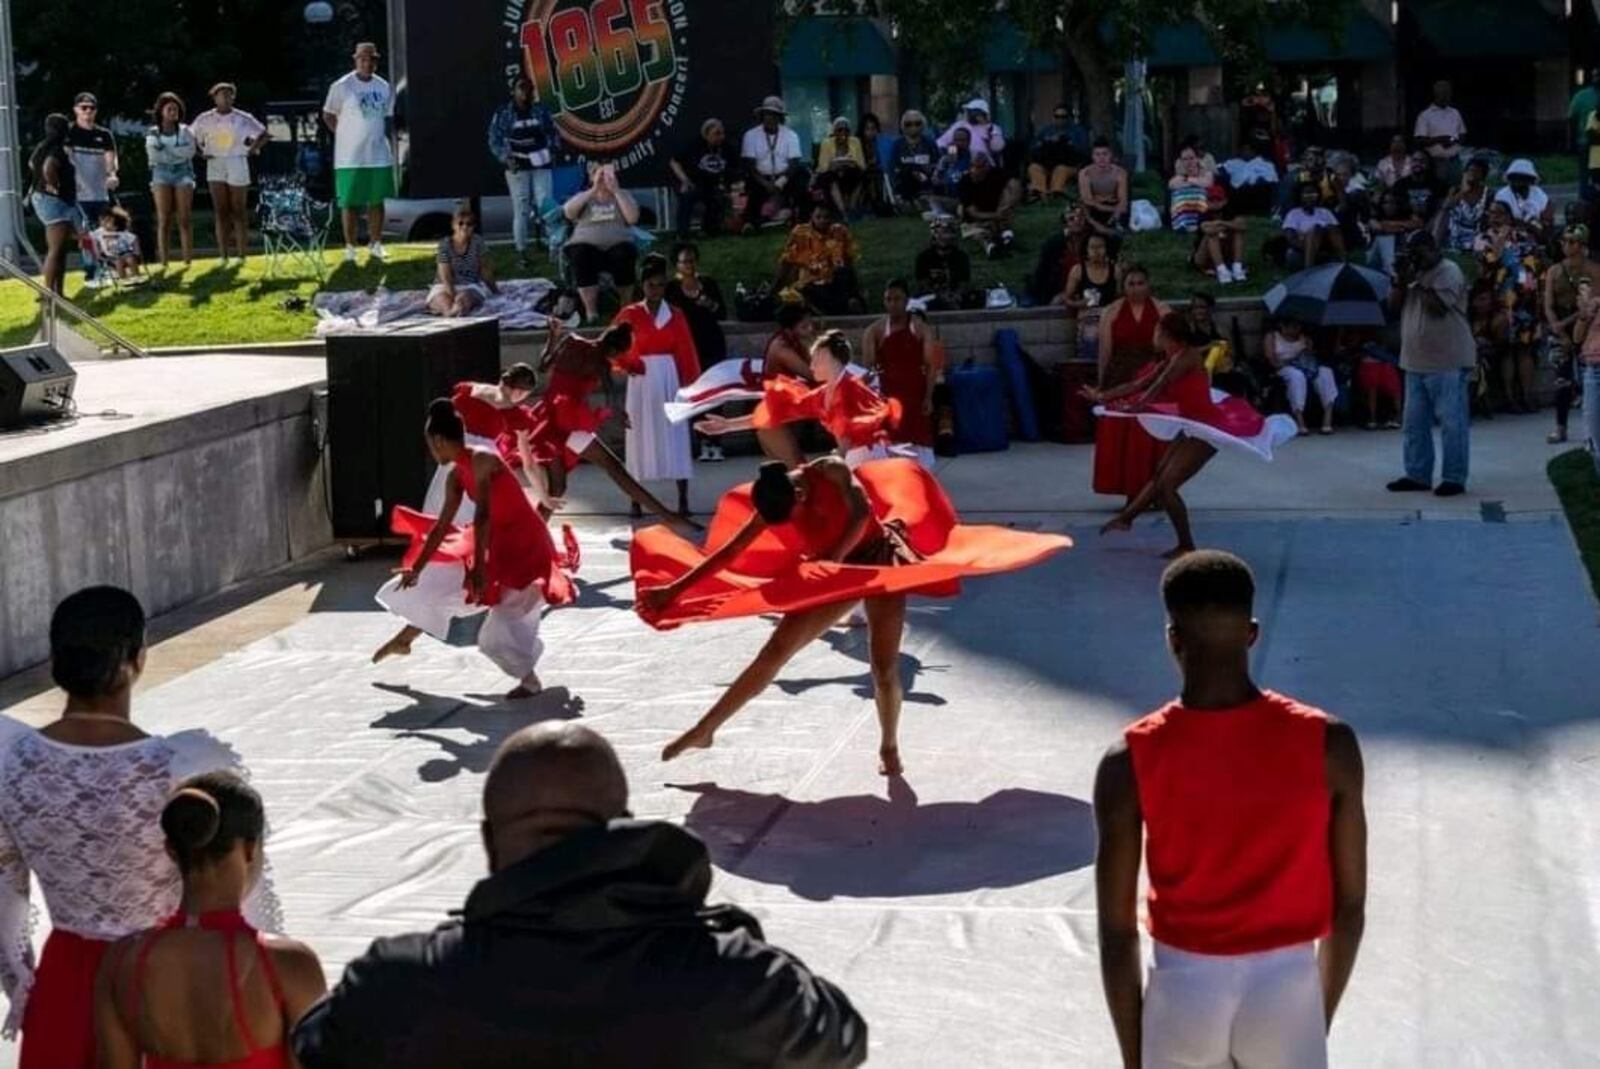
[392,0,778,197]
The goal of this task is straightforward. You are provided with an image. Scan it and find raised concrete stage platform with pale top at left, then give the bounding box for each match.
[0,354,330,675]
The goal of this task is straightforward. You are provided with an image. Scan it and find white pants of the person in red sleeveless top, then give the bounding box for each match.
[1141,943,1328,1069]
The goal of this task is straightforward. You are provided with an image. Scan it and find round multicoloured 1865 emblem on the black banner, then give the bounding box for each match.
[506,0,691,168]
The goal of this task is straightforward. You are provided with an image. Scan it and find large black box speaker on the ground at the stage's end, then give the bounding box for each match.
[328,318,501,539]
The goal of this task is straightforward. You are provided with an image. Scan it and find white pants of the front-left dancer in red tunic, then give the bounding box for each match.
[376,563,544,683]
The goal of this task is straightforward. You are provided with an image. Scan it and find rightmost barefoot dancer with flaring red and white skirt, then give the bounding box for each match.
[1083,312,1296,559]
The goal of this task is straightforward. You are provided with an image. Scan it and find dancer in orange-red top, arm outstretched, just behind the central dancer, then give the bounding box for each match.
[694,330,901,467]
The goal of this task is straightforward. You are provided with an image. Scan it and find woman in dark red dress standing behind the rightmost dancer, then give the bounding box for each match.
[1094,266,1168,501]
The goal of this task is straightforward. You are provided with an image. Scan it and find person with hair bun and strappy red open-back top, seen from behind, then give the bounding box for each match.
[94,773,328,1069]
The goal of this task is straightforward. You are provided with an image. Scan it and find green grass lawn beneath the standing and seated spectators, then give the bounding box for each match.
[0,196,1282,347]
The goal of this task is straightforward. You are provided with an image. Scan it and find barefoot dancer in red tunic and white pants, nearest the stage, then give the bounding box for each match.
[373,398,573,699]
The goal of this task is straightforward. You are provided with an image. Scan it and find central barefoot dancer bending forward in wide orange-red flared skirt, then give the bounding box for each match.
[630,456,1072,776]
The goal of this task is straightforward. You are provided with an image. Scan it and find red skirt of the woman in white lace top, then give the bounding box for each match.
[18,928,110,1069]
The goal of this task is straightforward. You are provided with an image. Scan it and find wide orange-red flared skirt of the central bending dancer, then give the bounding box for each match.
[629,458,1072,631]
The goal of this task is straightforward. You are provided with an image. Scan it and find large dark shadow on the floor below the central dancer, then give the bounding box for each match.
[672,776,1094,899]
